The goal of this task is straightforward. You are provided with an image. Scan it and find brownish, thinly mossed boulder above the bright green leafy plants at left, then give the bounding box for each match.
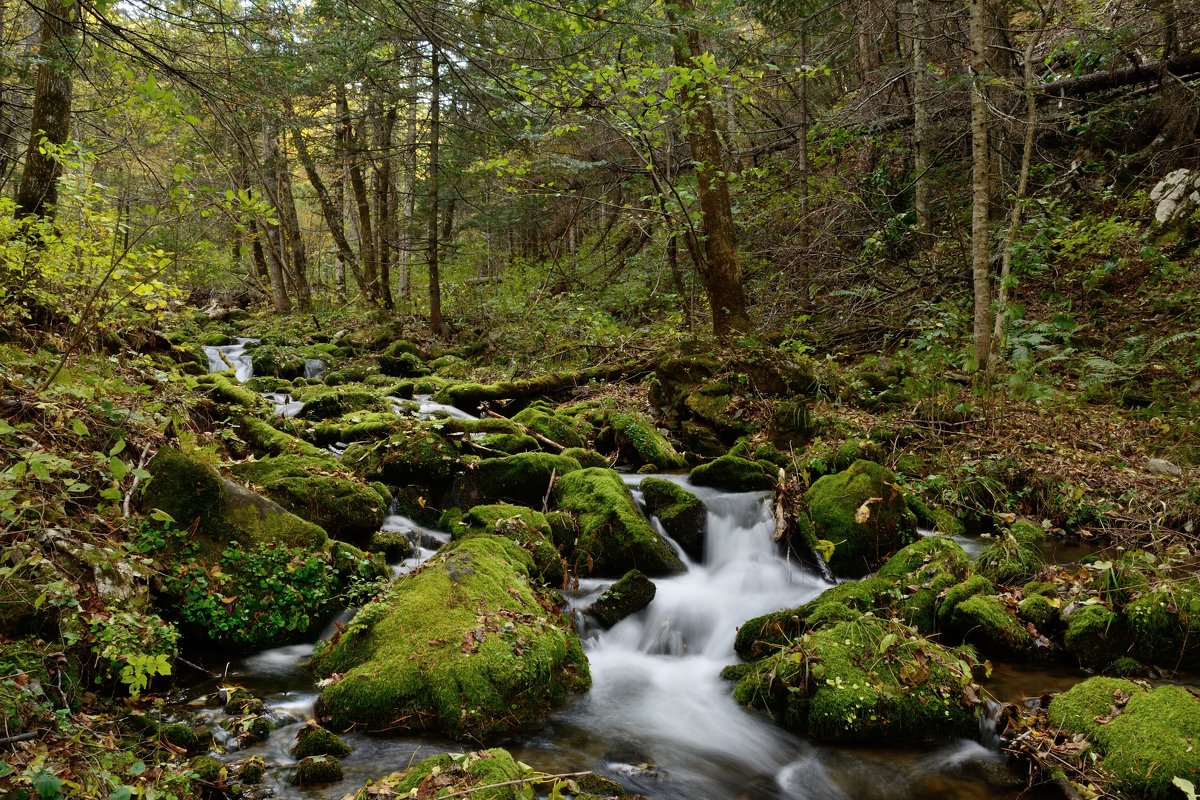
[140,447,328,557]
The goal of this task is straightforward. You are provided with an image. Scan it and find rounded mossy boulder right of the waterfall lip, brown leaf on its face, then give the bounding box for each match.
[804,461,917,577]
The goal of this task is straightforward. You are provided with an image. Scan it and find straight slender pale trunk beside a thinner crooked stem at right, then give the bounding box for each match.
[970,0,992,371]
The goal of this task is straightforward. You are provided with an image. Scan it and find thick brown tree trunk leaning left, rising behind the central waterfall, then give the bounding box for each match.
[668,0,750,336]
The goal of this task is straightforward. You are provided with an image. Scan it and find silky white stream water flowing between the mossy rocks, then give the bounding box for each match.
[194,348,1081,800]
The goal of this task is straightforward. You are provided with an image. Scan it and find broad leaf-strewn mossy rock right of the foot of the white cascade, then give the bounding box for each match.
[733,616,979,744]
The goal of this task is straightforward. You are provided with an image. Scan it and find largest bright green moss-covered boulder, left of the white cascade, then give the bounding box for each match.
[313,535,590,740]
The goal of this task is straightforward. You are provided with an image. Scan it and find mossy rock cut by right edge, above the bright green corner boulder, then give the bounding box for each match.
[1122,578,1200,668]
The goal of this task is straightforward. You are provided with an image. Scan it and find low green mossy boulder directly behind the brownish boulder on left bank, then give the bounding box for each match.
[230,455,386,545]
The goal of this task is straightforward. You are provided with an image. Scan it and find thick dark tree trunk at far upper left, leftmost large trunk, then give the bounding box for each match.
[16,0,78,217]
